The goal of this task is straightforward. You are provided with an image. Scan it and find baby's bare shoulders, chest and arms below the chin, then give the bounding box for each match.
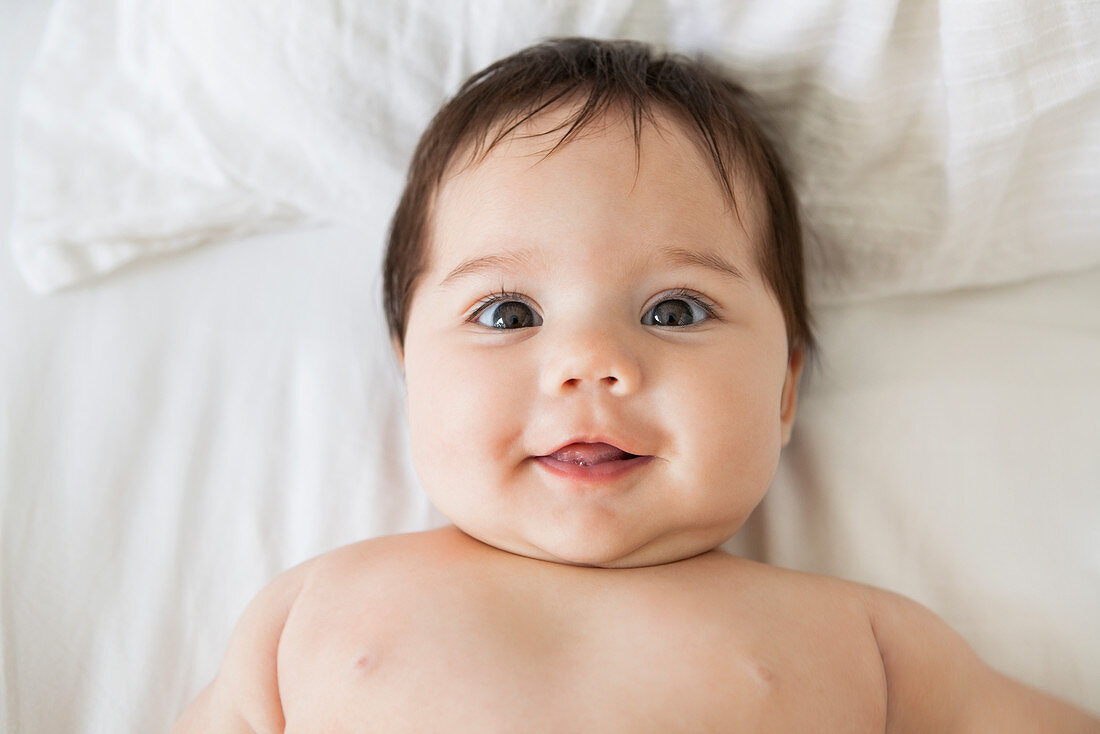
[175,526,1100,734]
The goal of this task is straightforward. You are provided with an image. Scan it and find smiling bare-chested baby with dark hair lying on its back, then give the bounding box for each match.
[167,39,1100,734]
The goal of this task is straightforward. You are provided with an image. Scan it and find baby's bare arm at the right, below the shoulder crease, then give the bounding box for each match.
[868,589,1100,734]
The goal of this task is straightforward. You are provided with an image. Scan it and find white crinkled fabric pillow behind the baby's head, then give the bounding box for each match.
[13,0,1100,303]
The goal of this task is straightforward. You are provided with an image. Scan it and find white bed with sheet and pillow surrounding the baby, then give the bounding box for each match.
[0,0,1100,734]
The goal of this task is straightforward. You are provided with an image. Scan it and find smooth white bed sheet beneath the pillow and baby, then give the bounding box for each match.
[0,0,1100,734]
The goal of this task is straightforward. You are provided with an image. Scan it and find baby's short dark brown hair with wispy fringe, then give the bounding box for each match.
[383,39,816,358]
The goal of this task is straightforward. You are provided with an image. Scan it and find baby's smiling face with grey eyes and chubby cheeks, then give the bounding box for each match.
[402,107,802,567]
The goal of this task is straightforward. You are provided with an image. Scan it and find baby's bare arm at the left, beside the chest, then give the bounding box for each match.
[172,562,310,734]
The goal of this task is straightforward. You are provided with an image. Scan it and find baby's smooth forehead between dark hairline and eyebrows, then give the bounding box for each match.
[429,106,759,285]
